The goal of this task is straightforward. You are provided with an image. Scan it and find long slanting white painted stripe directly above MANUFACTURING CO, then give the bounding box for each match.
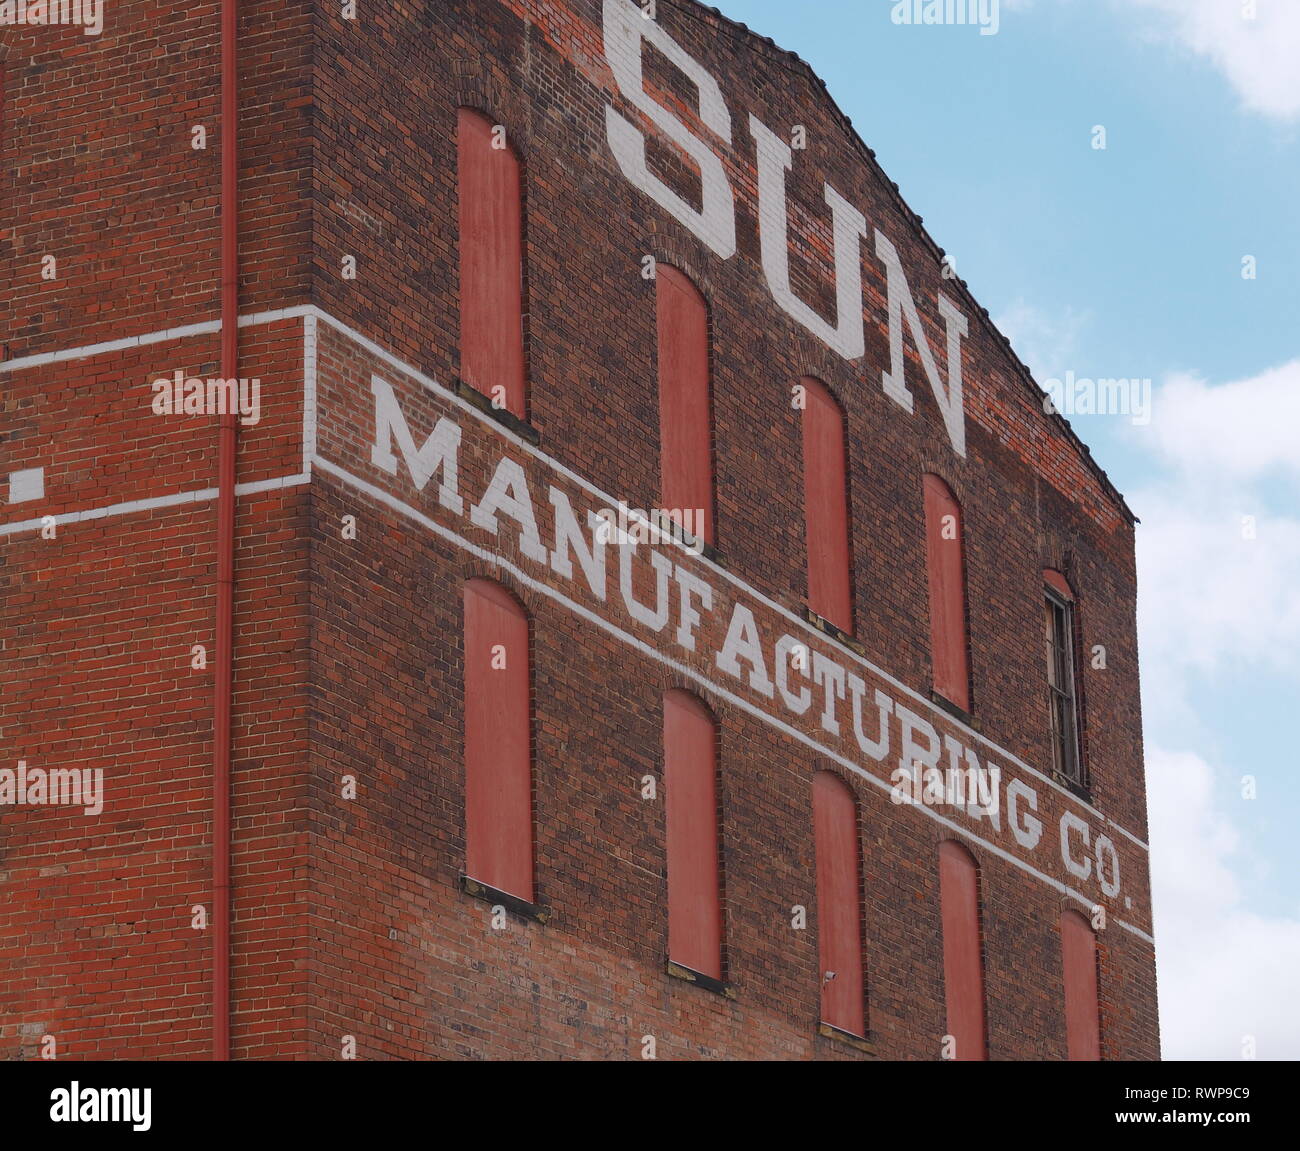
[301,300,1148,851]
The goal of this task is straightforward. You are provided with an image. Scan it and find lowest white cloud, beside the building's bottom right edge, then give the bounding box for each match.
[1147,745,1300,1060]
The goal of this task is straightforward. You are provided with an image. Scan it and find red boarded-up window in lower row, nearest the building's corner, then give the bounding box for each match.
[464,580,533,903]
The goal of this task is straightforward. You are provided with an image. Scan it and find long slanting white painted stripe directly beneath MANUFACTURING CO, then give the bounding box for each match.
[313,456,1156,944]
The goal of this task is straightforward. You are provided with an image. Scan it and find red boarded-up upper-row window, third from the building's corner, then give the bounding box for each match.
[800,376,853,632]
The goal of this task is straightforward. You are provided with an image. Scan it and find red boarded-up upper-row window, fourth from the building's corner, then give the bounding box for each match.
[924,475,971,711]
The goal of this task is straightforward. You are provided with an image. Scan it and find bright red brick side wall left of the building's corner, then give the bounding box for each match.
[0,0,313,1059]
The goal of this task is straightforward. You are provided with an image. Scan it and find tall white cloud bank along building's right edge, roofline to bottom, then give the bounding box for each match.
[1127,360,1300,1060]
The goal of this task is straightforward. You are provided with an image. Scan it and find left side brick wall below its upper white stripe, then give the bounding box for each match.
[0,320,308,1059]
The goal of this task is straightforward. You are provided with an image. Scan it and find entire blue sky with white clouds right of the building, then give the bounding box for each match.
[716,0,1300,1059]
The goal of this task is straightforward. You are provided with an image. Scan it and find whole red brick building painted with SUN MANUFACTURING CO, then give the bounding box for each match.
[0,0,1158,1060]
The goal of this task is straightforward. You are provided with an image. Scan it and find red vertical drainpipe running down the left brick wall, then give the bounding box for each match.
[212,0,239,1061]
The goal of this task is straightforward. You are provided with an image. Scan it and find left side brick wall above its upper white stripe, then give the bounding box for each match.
[0,0,317,359]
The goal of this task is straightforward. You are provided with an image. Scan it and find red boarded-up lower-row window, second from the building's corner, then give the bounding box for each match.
[663,691,723,979]
